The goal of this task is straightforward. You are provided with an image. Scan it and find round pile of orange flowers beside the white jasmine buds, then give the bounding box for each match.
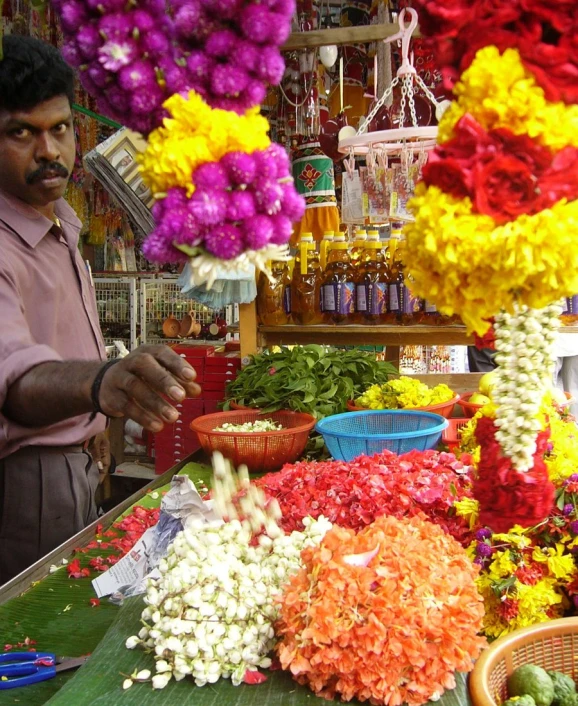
[276,517,486,706]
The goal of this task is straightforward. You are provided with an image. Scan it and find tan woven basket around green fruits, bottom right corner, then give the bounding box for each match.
[469,618,578,706]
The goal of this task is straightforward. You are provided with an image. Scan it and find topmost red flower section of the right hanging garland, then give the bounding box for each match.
[413,0,578,103]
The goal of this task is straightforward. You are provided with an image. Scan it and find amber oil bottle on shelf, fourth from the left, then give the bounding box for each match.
[355,231,388,324]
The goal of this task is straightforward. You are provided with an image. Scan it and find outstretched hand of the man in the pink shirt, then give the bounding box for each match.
[99,346,201,432]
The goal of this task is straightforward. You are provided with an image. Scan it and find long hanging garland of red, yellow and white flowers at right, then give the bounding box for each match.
[404,0,578,531]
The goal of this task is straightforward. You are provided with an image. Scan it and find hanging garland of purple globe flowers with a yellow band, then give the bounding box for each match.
[48,0,304,285]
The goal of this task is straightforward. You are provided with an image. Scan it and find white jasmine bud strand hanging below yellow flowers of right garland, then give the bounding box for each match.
[492,303,562,471]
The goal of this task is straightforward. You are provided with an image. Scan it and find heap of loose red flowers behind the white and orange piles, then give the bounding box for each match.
[255,451,472,546]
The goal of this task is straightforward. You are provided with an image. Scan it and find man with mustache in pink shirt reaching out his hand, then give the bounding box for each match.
[0,36,200,584]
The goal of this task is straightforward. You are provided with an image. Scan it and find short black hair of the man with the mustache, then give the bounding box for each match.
[0,35,74,112]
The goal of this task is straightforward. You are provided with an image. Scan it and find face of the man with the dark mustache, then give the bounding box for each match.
[0,96,76,211]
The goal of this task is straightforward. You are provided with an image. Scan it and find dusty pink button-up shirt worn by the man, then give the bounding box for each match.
[0,192,106,458]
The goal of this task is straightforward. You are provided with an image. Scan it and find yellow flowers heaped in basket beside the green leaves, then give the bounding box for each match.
[355,376,455,409]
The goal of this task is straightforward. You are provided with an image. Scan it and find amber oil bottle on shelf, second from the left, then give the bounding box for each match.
[291,233,323,326]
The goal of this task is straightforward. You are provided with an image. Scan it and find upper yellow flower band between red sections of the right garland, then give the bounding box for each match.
[438,46,578,151]
